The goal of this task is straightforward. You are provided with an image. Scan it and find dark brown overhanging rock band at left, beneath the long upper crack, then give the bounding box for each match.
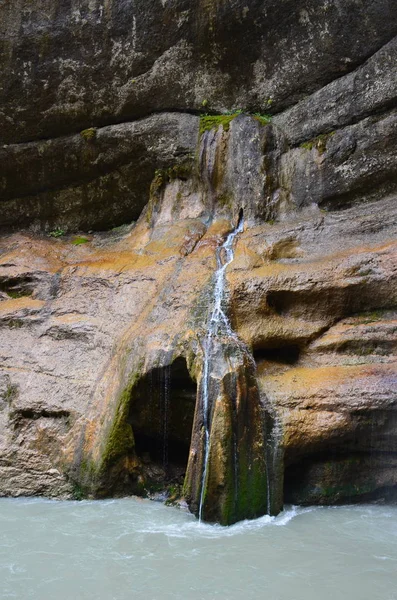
[0,113,198,230]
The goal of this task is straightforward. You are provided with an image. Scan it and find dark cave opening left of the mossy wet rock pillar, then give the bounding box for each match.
[128,358,197,484]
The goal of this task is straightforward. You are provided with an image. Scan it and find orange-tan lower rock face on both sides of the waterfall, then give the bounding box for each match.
[0,191,397,510]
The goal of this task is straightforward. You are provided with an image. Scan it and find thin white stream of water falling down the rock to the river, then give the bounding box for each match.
[199,215,244,521]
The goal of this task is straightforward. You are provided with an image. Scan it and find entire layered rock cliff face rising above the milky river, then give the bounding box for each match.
[0,0,397,524]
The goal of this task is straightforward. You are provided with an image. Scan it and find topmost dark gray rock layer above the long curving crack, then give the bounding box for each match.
[0,0,397,143]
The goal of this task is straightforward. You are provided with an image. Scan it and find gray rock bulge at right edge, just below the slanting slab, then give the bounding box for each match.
[279,111,397,211]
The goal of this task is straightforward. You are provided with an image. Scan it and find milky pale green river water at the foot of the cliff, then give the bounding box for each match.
[0,499,397,600]
